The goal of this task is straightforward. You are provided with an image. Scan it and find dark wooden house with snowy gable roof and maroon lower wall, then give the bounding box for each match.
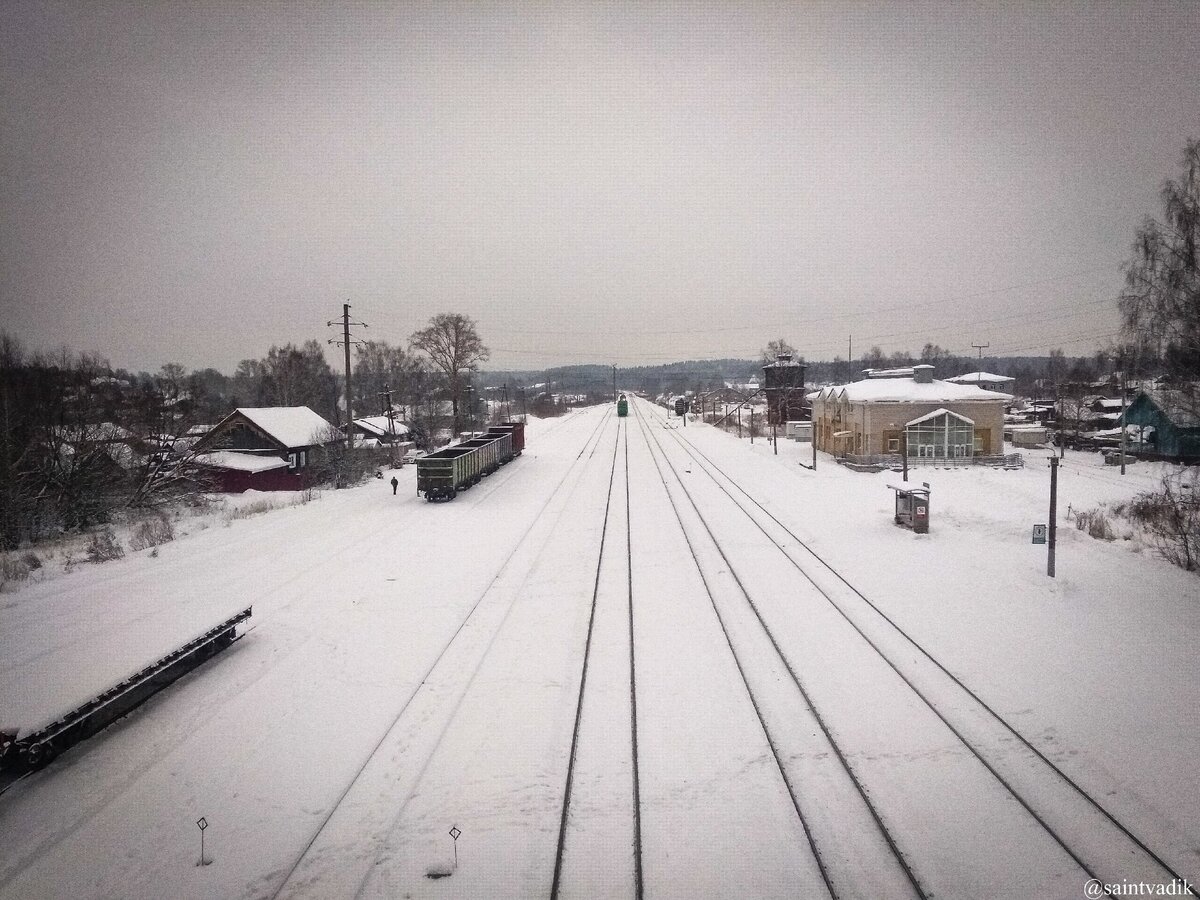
[193,407,344,493]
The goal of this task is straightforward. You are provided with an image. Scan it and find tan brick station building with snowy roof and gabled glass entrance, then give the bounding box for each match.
[809,365,1013,462]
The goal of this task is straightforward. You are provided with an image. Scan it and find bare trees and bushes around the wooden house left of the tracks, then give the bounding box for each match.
[0,313,487,550]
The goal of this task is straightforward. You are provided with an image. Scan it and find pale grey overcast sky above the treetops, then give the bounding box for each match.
[0,0,1200,372]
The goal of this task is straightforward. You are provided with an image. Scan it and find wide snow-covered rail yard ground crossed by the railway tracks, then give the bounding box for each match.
[0,401,1200,900]
